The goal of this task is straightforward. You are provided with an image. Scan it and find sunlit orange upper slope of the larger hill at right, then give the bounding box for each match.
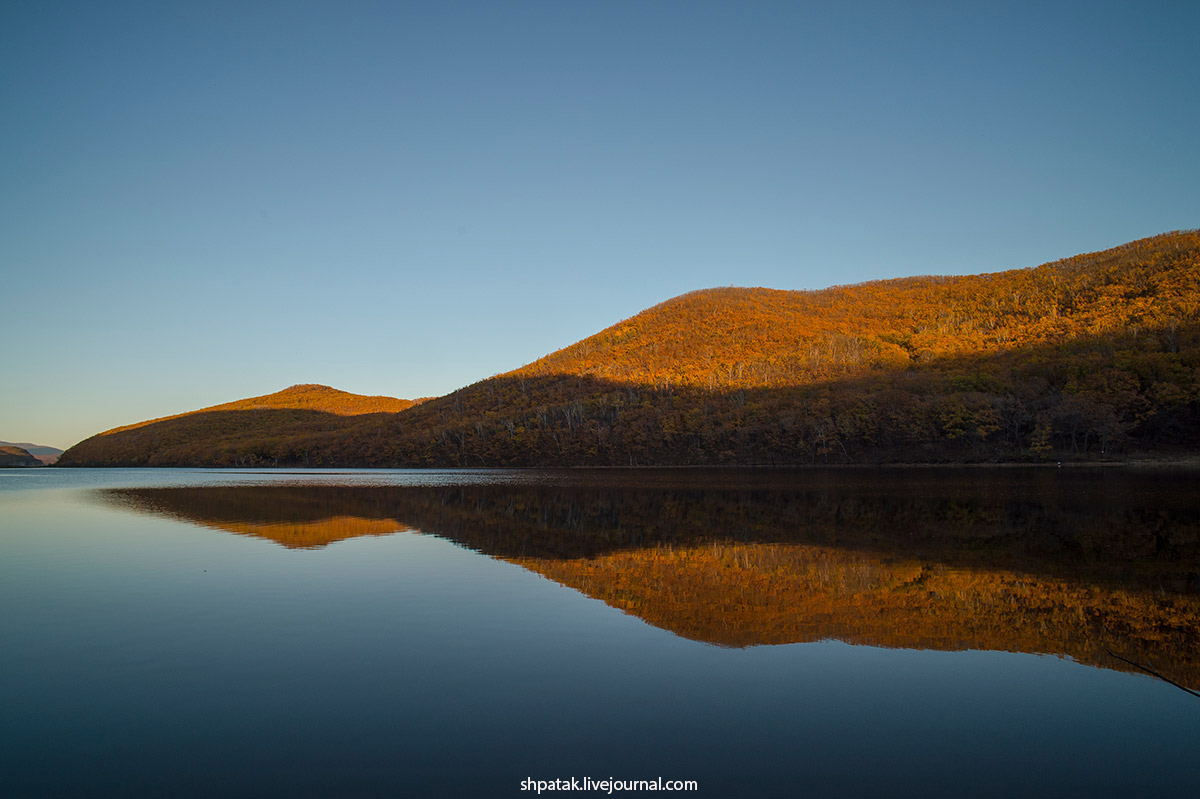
[514,233,1200,389]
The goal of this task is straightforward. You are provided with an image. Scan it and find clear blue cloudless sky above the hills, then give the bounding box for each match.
[0,0,1200,447]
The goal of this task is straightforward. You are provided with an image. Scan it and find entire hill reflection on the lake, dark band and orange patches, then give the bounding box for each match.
[103,469,1200,686]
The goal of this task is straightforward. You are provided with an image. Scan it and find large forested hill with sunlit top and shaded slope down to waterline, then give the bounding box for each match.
[60,232,1200,467]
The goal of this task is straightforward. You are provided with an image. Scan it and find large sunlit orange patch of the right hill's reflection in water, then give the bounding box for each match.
[514,543,1200,667]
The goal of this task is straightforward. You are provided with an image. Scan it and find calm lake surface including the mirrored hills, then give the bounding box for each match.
[0,469,1200,797]
